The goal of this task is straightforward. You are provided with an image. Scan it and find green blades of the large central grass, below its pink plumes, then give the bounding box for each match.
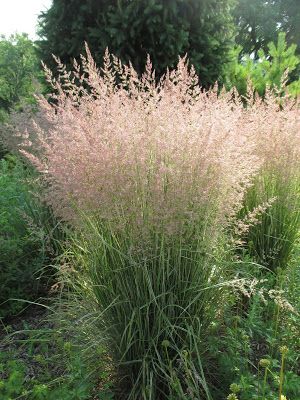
[67,222,232,400]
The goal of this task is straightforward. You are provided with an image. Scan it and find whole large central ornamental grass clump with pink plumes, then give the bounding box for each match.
[14,49,261,400]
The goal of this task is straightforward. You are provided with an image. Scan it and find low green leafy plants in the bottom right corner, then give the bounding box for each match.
[216,282,300,400]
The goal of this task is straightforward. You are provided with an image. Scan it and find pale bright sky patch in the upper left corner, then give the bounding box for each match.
[0,0,52,40]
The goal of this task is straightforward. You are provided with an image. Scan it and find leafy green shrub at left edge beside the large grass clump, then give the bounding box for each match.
[0,156,61,317]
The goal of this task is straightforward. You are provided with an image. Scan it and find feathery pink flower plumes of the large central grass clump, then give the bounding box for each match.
[19,47,259,238]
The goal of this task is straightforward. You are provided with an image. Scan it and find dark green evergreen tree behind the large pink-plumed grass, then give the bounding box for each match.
[39,0,235,86]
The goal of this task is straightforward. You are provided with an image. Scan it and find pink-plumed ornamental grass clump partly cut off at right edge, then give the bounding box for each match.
[238,92,300,272]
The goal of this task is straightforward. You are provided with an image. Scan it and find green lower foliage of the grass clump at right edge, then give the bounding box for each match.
[242,170,300,271]
